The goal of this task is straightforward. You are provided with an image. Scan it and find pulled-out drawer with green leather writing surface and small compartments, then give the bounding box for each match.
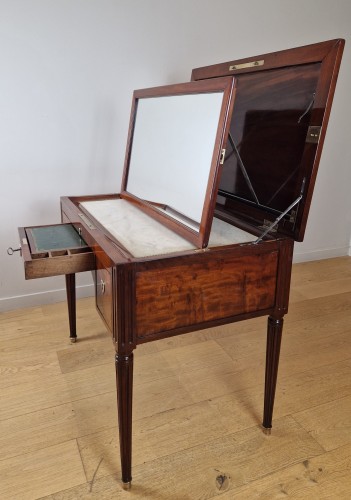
[18,224,95,279]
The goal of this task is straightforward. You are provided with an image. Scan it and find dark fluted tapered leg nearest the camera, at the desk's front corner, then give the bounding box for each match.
[116,353,133,485]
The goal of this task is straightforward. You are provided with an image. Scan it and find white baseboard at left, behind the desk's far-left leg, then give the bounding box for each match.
[0,284,94,312]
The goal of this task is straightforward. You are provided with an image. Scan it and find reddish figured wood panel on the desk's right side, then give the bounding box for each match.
[136,251,278,338]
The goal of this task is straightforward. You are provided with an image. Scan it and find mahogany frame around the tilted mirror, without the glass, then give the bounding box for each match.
[120,77,236,248]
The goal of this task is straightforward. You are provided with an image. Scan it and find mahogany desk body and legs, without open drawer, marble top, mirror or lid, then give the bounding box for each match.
[57,195,293,483]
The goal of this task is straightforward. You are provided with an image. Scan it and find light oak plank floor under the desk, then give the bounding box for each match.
[0,257,351,500]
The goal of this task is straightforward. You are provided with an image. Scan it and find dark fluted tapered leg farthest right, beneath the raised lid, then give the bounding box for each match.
[263,316,283,434]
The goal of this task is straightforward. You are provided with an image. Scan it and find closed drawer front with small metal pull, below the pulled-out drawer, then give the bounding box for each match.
[95,260,113,333]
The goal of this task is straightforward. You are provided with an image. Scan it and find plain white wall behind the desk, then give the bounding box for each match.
[0,0,351,310]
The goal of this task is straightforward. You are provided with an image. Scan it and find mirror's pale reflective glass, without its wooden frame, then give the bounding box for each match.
[127,92,223,227]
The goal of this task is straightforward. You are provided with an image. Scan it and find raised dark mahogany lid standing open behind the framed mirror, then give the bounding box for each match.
[192,39,344,241]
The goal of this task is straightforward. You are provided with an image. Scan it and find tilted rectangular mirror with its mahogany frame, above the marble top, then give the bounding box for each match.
[121,78,234,247]
